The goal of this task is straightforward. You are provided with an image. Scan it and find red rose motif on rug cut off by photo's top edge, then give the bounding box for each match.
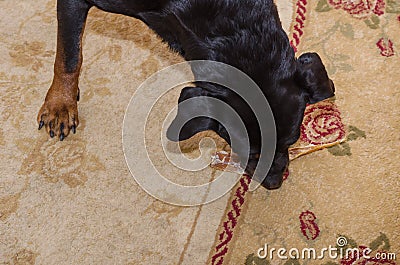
[329,0,385,19]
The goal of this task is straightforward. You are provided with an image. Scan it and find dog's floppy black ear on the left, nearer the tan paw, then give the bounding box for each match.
[167,87,219,142]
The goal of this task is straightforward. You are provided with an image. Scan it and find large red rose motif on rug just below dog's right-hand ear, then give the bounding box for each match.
[300,101,346,145]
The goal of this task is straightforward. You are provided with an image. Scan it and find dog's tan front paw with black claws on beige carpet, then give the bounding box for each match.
[37,89,79,141]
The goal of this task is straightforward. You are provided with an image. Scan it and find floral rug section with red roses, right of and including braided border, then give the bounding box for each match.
[209,0,400,265]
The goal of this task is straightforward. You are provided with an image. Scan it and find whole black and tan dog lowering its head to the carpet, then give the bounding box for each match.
[38,0,334,189]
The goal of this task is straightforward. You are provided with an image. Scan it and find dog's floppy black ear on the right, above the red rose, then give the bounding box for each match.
[296,53,335,104]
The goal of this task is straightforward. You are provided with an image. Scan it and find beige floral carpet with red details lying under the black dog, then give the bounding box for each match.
[0,0,400,264]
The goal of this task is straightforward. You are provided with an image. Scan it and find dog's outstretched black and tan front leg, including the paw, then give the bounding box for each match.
[37,0,91,141]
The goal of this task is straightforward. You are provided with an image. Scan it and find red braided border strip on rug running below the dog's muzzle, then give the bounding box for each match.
[211,175,251,265]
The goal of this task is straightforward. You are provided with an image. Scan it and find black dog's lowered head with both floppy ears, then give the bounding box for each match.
[167,53,335,189]
